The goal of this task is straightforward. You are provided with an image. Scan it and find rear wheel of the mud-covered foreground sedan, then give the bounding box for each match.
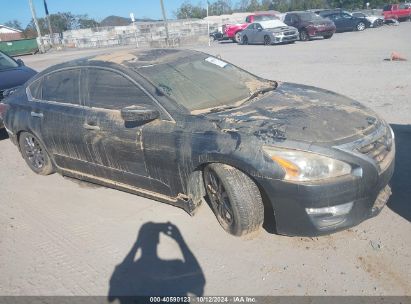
[19,132,55,175]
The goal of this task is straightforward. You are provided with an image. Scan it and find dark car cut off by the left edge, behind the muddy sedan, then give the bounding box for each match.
[0,52,37,129]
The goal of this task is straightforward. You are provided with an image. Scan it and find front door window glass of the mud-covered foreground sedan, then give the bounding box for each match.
[85,68,153,110]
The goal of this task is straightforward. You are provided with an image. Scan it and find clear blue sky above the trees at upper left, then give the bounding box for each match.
[0,0,196,27]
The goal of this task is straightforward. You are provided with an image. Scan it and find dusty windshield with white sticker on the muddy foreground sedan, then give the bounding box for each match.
[137,54,275,114]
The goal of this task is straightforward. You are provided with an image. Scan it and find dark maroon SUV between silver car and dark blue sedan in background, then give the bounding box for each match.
[284,11,335,41]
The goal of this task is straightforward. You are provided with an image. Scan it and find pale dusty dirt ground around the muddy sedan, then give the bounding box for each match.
[0,22,411,296]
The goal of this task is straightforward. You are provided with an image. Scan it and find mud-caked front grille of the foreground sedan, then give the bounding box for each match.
[357,128,393,169]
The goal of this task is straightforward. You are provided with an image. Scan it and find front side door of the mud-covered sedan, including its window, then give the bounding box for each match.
[83,67,175,195]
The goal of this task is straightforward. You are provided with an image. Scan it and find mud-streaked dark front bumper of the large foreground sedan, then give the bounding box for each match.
[258,141,395,236]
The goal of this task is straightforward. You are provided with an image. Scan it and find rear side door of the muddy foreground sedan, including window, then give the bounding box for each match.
[29,68,87,171]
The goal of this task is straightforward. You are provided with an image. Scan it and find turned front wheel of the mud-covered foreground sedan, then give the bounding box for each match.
[204,163,264,236]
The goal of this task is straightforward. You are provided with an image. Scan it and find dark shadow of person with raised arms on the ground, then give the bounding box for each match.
[108,222,206,303]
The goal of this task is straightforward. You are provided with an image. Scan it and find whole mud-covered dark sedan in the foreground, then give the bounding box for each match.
[0,49,395,236]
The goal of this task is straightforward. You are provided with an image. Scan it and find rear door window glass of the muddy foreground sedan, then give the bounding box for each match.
[41,69,80,105]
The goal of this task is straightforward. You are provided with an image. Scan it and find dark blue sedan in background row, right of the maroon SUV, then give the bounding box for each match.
[318,9,371,32]
